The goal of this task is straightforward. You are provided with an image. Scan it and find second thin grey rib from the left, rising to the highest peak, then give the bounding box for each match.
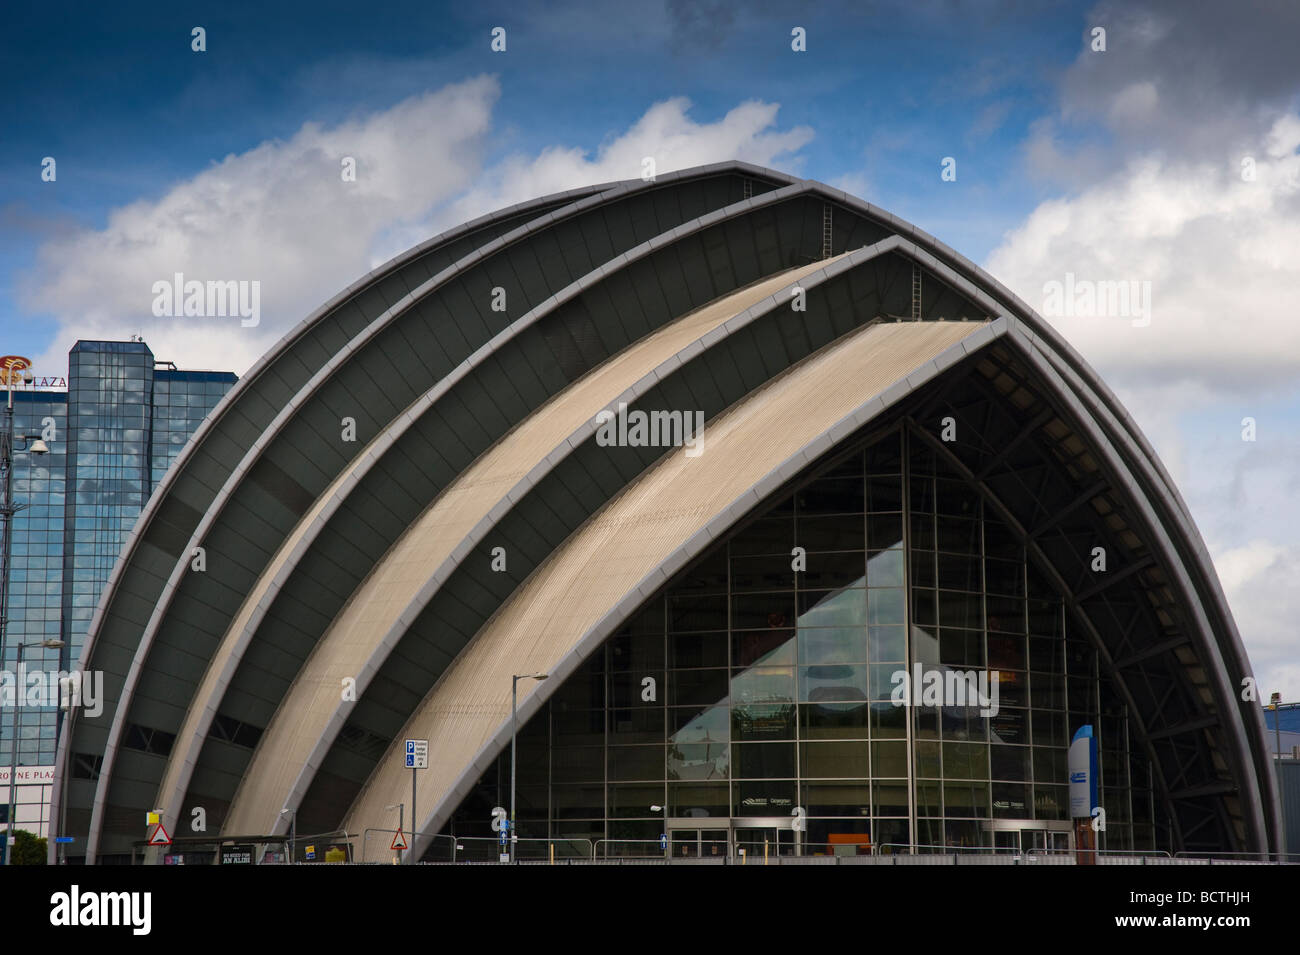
[78,164,785,858]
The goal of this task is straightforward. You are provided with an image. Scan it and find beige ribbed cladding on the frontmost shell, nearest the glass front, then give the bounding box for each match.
[346,324,978,852]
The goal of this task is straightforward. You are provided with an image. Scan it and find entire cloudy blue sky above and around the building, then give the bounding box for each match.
[0,0,1300,699]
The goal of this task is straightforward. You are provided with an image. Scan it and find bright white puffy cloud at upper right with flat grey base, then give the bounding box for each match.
[988,116,1300,391]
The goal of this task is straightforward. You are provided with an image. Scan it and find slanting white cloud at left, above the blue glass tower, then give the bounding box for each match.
[22,77,499,372]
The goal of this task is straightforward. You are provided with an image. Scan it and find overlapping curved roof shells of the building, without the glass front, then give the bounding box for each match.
[60,162,1277,858]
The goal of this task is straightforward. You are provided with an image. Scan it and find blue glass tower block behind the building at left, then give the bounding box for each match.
[0,342,237,834]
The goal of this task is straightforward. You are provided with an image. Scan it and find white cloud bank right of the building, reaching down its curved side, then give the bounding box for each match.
[987,97,1300,700]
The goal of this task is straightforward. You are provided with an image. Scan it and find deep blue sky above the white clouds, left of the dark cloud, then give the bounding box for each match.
[0,3,1086,353]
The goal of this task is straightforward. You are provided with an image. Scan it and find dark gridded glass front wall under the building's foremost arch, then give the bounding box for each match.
[444,431,1153,854]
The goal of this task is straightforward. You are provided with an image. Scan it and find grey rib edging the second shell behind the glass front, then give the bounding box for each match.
[233,236,992,829]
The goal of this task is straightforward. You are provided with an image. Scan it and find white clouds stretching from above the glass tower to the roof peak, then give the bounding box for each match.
[21,85,813,373]
